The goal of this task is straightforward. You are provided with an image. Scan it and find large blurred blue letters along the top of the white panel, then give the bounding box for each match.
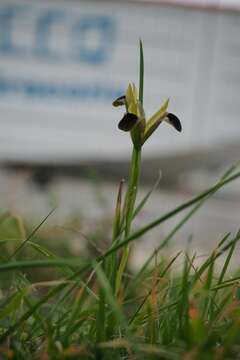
[0,5,116,65]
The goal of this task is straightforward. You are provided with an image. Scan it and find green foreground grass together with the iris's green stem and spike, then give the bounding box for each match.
[0,42,240,360]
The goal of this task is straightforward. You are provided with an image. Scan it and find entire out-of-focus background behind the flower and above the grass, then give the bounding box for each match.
[0,0,240,262]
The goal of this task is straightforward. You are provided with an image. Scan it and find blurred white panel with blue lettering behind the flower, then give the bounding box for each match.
[0,0,240,162]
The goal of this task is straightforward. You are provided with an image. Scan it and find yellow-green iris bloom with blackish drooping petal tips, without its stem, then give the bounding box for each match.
[113,84,182,147]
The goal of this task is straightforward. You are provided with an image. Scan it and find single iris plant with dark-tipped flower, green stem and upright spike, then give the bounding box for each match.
[113,41,182,291]
